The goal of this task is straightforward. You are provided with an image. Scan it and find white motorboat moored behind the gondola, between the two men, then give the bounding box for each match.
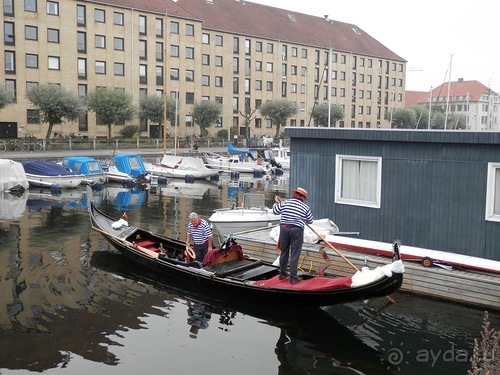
[208,193,281,236]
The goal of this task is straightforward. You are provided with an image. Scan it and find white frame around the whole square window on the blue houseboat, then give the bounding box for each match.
[335,155,382,208]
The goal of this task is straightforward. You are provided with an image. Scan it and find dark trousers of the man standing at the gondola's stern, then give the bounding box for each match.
[280,225,304,280]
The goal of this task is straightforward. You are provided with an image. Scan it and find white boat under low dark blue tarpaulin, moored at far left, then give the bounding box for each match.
[21,160,85,189]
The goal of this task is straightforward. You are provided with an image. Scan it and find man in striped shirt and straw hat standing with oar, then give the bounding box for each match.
[273,187,313,284]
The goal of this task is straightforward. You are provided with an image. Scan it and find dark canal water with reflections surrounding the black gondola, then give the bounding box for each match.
[0,176,500,375]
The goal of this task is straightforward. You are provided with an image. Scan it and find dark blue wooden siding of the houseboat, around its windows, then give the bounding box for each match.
[286,127,500,260]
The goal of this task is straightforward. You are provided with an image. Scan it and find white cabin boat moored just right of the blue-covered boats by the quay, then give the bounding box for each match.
[144,155,219,179]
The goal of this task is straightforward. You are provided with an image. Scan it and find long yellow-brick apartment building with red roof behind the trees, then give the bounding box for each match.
[0,0,406,137]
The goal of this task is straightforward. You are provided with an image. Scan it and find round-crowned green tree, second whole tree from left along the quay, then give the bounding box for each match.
[87,88,136,139]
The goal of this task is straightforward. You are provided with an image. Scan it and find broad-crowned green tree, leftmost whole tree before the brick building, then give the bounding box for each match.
[26,84,87,139]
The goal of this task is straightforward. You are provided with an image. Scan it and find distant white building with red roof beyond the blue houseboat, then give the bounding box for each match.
[406,79,500,130]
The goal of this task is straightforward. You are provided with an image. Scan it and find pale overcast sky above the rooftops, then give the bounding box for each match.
[249,0,500,92]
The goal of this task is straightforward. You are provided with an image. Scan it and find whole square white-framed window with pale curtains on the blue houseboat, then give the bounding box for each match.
[335,155,382,208]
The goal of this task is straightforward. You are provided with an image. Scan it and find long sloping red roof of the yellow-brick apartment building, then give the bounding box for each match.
[93,0,406,62]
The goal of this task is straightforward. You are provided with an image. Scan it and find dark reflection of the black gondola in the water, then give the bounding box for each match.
[90,251,390,375]
